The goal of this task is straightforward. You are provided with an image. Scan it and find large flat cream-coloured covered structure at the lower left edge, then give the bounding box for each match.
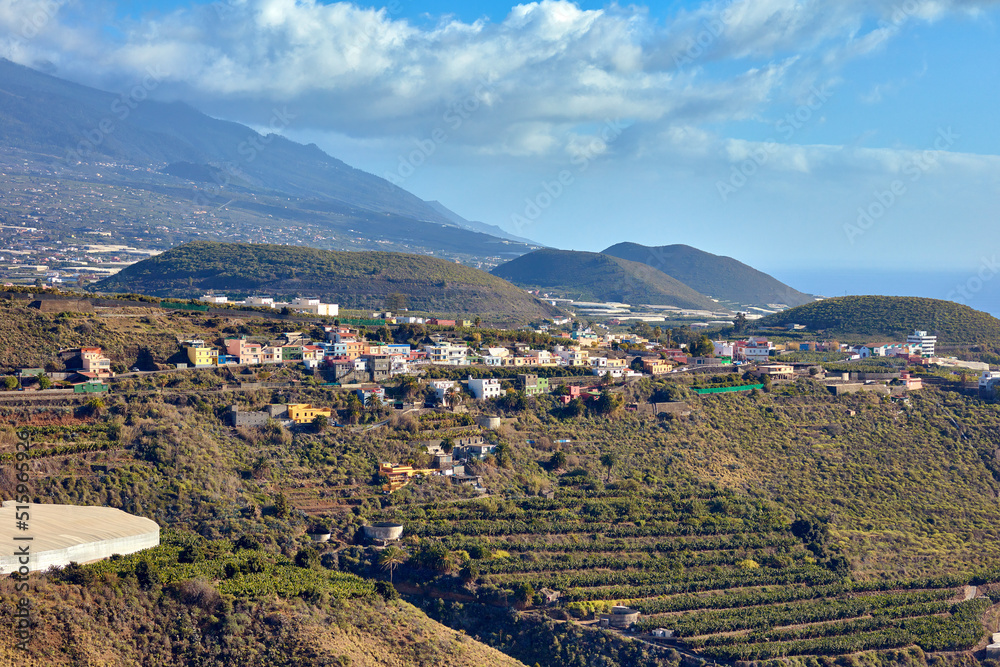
[0,500,160,575]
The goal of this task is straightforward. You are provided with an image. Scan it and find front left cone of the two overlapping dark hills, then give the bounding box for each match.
[493,250,720,310]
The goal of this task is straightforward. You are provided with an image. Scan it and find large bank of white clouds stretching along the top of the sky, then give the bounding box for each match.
[0,0,995,169]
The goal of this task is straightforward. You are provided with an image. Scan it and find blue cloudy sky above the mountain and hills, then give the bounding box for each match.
[0,0,1000,306]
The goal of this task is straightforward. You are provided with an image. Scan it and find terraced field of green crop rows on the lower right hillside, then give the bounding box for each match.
[376,483,1000,660]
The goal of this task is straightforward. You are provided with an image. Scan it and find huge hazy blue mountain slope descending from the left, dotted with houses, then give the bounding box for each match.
[0,59,531,266]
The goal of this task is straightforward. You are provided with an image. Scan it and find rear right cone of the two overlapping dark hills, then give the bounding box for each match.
[604,243,812,307]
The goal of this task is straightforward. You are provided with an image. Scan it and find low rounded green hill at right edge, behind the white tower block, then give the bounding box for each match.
[757,296,1000,343]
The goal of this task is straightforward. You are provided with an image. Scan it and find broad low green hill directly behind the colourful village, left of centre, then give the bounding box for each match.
[96,241,559,321]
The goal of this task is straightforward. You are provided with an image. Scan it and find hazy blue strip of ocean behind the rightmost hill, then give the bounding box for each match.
[769,266,1000,317]
